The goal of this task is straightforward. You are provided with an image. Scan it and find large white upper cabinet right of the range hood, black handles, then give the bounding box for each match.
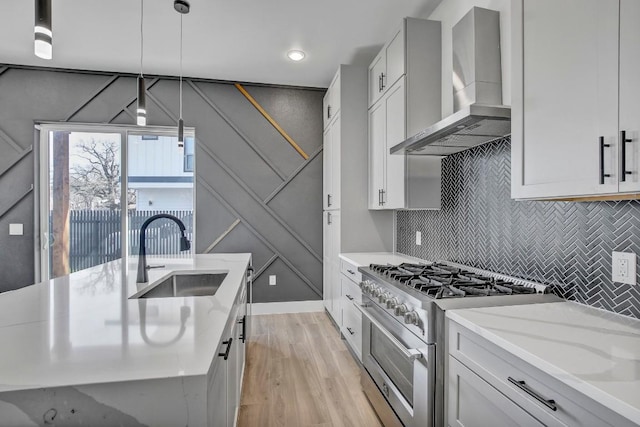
[511,0,640,199]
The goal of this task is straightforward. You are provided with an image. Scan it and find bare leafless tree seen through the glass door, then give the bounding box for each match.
[70,138,135,210]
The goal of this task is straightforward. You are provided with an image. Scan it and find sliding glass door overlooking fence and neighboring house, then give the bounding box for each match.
[38,124,195,280]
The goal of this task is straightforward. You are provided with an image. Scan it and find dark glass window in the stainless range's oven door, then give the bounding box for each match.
[371,325,413,407]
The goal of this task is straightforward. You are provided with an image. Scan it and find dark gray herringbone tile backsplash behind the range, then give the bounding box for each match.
[397,138,640,318]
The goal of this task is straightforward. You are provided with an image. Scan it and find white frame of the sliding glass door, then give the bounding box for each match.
[34,121,197,283]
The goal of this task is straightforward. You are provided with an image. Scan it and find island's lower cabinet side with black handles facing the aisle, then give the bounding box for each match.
[207,276,247,427]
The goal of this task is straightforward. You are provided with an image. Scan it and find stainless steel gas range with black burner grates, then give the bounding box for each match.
[356,262,560,427]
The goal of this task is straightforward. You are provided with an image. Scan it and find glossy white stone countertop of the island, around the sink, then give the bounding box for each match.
[0,254,251,392]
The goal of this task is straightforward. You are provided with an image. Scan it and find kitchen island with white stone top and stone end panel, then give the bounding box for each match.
[0,254,251,426]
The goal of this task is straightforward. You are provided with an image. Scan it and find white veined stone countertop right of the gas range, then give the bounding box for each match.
[446,302,640,425]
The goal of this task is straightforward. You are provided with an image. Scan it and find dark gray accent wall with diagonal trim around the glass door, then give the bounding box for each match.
[0,65,324,302]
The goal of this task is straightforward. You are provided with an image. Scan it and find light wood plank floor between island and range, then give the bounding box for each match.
[238,313,380,427]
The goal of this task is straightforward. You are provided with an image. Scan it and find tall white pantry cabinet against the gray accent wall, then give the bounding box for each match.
[322,65,393,327]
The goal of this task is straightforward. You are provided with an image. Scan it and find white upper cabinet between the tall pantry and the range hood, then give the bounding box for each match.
[368,18,442,210]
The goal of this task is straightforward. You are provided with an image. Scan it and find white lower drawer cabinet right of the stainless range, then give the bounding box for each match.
[445,320,634,427]
